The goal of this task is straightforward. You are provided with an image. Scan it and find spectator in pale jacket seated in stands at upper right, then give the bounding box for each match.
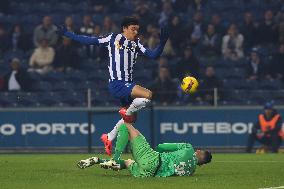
[222,24,244,61]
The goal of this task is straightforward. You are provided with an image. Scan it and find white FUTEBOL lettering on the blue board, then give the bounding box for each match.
[160,122,253,135]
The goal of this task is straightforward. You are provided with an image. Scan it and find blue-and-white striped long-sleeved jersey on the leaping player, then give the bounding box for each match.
[64,31,165,82]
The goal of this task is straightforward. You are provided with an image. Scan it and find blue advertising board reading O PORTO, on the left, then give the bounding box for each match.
[0,111,150,147]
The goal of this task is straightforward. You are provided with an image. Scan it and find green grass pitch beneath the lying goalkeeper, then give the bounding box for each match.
[0,154,284,189]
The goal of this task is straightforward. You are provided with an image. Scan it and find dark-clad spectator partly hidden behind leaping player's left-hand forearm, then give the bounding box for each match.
[80,15,95,57]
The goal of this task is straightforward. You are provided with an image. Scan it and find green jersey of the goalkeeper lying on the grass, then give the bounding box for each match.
[155,143,198,177]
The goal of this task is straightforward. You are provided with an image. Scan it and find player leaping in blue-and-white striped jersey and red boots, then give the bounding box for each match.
[58,16,169,155]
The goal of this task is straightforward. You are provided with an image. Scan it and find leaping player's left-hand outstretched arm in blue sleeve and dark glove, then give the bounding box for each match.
[57,25,110,45]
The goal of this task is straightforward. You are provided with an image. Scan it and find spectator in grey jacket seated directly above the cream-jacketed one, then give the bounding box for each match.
[33,16,58,47]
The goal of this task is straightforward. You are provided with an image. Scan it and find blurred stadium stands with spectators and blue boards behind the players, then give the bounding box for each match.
[0,0,284,153]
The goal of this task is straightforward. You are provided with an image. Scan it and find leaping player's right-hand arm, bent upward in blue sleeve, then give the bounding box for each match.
[139,27,169,59]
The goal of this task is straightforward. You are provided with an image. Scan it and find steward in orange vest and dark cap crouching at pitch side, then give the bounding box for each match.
[246,103,284,153]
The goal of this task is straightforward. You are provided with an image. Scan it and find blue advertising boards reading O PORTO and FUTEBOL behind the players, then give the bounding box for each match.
[0,108,284,148]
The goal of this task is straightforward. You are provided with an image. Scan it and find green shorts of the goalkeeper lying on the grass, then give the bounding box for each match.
[129,135,159,177]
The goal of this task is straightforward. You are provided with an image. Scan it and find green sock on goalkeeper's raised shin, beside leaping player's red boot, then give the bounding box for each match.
[113,124,129,163]
